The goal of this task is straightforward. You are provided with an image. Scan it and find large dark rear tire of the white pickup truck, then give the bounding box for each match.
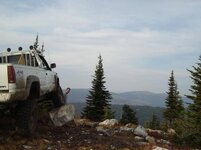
[17,99,38,136]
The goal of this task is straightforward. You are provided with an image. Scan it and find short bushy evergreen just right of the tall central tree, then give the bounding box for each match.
[120,104,138,124]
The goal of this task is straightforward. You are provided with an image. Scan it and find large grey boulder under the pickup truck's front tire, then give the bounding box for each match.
[49,105,75,126]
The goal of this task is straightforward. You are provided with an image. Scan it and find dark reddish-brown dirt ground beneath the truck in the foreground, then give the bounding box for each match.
[0,115,157,150]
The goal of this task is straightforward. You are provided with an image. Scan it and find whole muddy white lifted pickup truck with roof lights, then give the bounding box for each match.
[0,46,65,134]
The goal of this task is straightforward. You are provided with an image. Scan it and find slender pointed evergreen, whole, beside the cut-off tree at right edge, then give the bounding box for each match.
[164,71,184,128]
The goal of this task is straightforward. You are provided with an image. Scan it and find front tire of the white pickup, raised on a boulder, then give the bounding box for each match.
[52,85,65,108]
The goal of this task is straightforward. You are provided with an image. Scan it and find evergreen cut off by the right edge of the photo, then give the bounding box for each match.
[186,55,201,148]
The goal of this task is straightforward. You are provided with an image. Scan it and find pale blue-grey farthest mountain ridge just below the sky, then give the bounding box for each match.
[68,89,167,107]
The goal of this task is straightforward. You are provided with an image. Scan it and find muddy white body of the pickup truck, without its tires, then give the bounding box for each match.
[0,48,57,102]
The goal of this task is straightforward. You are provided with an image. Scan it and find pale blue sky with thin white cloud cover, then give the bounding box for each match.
[0,0,201,94]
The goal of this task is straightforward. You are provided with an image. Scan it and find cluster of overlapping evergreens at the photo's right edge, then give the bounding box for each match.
[164,56,201,148]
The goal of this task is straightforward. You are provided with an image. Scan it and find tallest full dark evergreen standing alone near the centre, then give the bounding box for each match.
[82,55,112,121]
